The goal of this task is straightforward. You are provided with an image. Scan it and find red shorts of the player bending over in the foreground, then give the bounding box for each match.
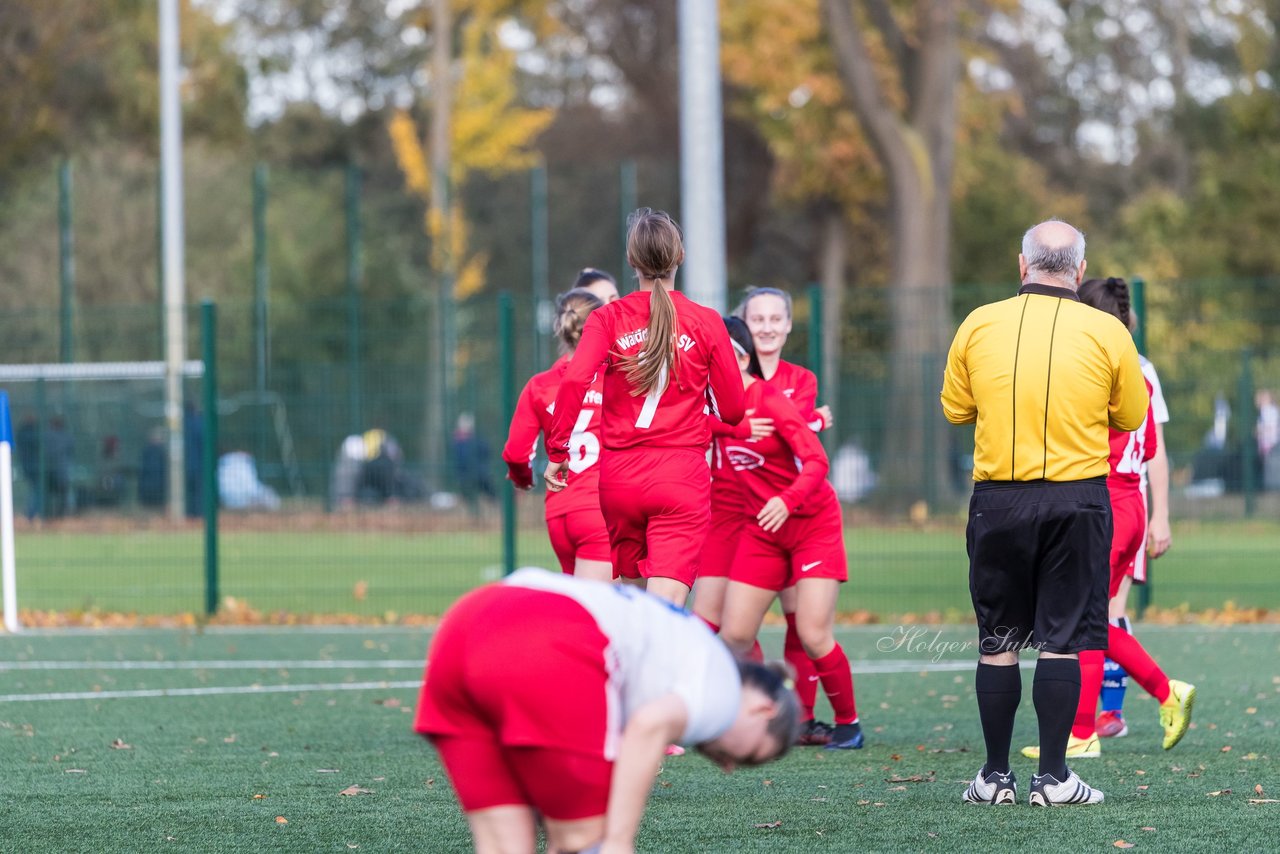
[413,584,617,821]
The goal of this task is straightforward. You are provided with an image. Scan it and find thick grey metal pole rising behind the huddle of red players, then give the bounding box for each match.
[677,0,727,311]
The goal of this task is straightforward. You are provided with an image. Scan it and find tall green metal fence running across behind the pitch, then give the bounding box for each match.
[0,155,1280,617]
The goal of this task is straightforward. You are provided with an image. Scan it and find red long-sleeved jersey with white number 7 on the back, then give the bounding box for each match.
[547,291,742,462]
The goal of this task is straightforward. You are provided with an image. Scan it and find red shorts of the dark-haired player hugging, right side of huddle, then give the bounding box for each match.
[728,497,849,590]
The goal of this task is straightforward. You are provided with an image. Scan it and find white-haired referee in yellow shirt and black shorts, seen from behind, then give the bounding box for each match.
[942,220,1148,807]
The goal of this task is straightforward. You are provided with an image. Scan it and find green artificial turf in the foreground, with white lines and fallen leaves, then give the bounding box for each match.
[0,625,1280,853]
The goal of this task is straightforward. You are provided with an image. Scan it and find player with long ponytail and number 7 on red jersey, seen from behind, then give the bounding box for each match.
[545,207,742,604]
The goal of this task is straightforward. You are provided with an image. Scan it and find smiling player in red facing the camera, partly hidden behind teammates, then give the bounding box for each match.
[735,288,835,744]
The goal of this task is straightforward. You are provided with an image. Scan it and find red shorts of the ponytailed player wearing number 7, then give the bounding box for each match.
[598,448,712,586]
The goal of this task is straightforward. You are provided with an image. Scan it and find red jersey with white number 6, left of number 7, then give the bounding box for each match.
[502,356,604,519]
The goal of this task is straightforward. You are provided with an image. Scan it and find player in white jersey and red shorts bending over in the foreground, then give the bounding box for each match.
[413,568,796,853]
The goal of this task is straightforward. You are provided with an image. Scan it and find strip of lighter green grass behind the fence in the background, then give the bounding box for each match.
[17,521,1280,621]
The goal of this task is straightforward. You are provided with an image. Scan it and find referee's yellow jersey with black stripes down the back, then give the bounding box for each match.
[942,283,1148,480]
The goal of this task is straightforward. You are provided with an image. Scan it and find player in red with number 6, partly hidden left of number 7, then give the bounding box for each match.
[502,288,617,581]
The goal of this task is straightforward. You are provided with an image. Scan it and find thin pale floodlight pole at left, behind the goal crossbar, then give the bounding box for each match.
[160,0,187,519]
